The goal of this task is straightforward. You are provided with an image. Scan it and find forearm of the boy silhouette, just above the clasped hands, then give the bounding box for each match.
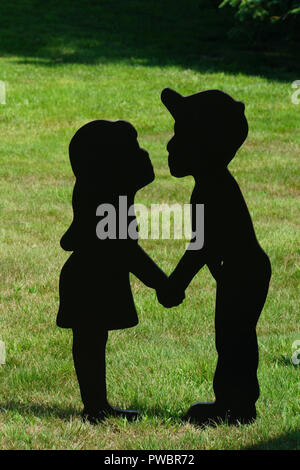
[169,248,208,290]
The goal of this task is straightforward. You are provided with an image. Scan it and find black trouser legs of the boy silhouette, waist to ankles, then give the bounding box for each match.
[213,269,271,408]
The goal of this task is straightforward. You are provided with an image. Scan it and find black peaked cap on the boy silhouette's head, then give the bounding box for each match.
[161,88,245,120]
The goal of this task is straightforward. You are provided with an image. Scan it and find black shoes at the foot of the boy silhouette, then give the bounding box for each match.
[186,402,256,427]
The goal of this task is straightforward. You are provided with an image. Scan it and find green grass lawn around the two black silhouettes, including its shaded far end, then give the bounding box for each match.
[0,0,300,450]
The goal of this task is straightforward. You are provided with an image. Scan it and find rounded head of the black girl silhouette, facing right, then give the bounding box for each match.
[70,120,154,196]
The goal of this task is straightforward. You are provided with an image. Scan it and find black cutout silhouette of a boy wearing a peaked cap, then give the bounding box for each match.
[158,88,271,425]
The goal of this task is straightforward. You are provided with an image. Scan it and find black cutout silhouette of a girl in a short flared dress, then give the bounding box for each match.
[57,120,183,423]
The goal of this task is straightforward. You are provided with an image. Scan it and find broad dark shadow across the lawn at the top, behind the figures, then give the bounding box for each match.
[0,0,300,81]
